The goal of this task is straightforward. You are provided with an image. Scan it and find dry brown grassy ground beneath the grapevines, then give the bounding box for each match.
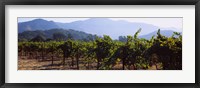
[18,56,161,70]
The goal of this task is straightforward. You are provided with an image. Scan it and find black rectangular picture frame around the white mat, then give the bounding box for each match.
[0,0,200,88]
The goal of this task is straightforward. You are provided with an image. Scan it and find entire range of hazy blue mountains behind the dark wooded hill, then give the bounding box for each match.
[18,18,181,39]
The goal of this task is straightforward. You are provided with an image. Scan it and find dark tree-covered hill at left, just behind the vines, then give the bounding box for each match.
[18,29,95,41]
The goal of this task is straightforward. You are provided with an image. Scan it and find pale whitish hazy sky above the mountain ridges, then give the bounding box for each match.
[18,18,182,30]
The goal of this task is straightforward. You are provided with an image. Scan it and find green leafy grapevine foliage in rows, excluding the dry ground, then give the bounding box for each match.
[18,29,182,70]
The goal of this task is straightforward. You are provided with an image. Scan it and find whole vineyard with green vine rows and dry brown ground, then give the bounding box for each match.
[18,29,182,70]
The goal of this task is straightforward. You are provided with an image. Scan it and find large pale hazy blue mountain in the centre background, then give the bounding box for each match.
[55,18,161,39]
